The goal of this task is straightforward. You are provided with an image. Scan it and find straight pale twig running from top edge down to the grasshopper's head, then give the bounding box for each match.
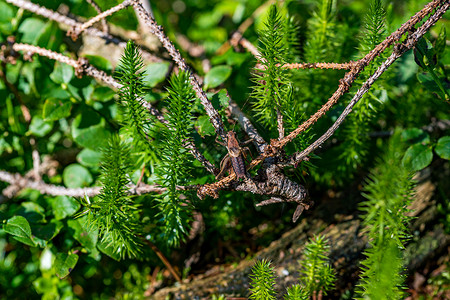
[131,0,226,141]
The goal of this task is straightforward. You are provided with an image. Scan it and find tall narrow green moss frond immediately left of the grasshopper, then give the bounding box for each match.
[159,72,195,245]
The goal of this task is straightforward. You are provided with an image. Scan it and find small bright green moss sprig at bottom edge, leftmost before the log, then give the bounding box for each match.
[249,259,276,300]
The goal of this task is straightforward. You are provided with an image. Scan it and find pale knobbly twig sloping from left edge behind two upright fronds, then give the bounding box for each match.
[8,43,218,174]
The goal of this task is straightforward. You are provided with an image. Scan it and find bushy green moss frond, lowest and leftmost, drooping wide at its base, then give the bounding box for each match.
[81,136,143,258]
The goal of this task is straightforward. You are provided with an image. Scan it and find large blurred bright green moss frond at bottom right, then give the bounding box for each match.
[357,132,413,299]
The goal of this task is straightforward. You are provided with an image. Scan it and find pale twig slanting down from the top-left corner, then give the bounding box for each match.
[5,0,163,62]
